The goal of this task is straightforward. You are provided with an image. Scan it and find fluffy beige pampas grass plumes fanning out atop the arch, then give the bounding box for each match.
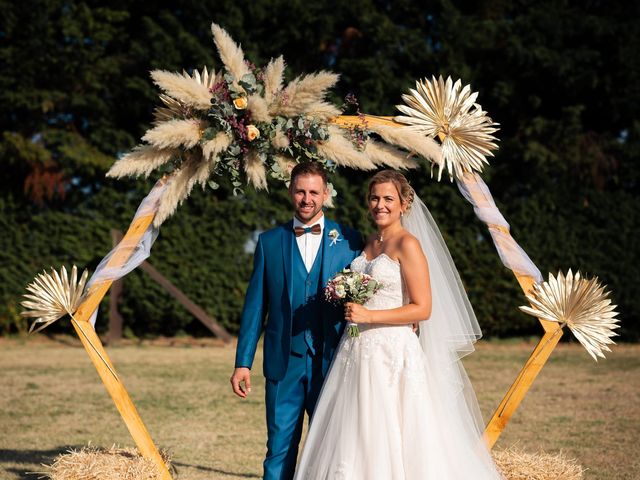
[108,23,450,226]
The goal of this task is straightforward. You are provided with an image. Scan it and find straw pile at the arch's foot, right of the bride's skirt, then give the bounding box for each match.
[492,447,584,480]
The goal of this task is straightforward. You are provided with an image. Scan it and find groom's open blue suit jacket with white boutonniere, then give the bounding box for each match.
[235,217,362,380]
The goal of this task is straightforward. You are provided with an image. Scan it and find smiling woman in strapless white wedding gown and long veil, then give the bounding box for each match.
[295,170,501,480]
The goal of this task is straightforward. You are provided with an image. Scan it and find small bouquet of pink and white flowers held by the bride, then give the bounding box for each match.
[324,268,382,337]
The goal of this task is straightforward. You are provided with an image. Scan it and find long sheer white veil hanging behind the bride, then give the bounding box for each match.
[402,196,493,469]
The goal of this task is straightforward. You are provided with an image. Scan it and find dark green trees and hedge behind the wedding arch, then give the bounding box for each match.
[0,0,640,340]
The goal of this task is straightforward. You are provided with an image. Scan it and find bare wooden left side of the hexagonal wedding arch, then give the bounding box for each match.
[72,215,171,480]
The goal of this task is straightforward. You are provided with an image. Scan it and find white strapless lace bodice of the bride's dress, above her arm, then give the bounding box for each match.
[351,252,404,310]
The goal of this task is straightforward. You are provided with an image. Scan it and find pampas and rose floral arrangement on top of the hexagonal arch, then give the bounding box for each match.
[107,24,430,226]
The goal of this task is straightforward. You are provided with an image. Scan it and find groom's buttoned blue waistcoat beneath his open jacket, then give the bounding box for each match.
[291,245,323,355]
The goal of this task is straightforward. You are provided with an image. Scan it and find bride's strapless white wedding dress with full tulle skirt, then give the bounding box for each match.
[295,254,501,480]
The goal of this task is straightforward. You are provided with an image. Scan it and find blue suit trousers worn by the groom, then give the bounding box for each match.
[264,350,324,480]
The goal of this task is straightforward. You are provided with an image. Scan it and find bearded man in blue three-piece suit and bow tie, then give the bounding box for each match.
[231,162,362,480]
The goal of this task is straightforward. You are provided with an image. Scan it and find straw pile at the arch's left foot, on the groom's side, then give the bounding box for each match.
[45,445,171,480]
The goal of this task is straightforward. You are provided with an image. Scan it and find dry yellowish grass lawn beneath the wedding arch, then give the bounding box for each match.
[0,336,640,480]
